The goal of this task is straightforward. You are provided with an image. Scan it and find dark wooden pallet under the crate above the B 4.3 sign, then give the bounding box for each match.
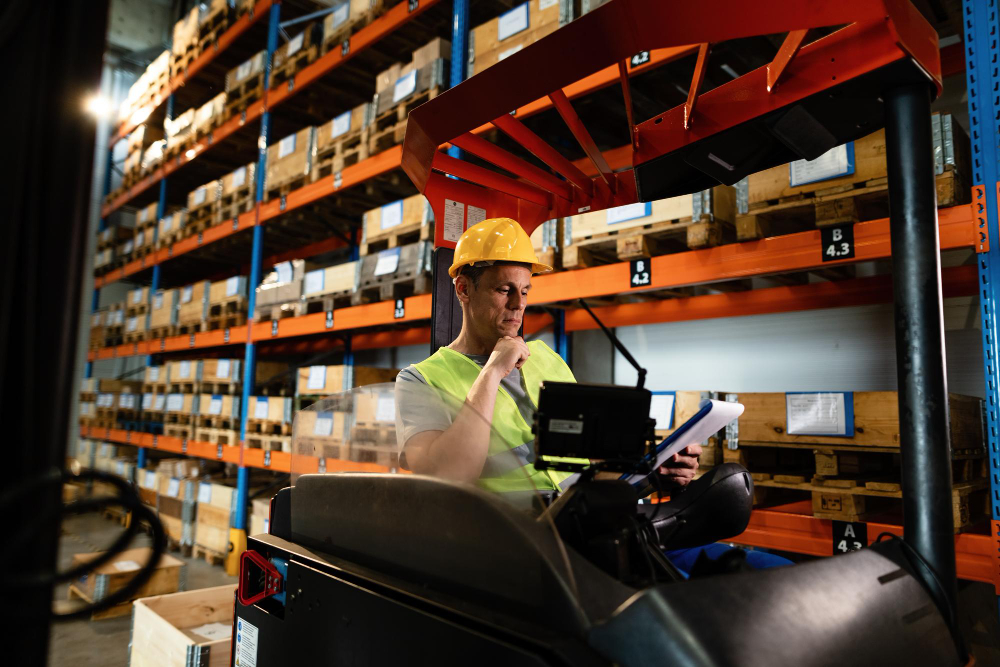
[736,170,971,241]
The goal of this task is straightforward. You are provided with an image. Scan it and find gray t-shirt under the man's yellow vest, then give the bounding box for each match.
[396,354,535,450]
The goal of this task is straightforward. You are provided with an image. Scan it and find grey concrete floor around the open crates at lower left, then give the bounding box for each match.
[49,515,236,667]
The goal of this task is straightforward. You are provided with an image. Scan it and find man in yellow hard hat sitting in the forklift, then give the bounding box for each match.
[396,218,701,491]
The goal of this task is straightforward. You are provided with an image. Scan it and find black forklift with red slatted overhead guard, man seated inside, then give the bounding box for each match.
[231,0,969,667]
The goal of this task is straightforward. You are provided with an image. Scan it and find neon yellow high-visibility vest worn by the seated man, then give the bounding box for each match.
[415,340,576,492]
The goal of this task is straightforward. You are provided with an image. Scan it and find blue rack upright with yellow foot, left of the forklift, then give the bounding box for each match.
[226,4,281,575]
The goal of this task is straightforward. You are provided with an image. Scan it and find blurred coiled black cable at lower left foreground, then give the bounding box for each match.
[0,469,167,621]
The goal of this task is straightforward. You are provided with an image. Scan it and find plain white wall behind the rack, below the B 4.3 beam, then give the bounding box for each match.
[614,298,985,397]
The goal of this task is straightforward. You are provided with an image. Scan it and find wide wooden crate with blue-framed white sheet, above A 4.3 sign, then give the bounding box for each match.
[738,391,985,451]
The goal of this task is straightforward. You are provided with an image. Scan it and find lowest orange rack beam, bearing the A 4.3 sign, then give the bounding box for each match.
[730,500,997,585]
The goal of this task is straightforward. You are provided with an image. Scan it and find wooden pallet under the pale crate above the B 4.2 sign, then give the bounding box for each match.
[562,216,733,269]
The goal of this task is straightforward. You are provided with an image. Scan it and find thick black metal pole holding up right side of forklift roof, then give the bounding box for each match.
[884,83,957,606]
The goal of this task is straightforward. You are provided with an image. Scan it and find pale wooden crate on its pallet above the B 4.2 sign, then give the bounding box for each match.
[562,185,736,269]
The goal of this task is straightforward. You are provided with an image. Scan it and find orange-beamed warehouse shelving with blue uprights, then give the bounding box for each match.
[81,0,1000,600]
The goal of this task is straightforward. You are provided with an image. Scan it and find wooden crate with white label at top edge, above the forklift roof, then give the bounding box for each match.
[469,0,565,76]
